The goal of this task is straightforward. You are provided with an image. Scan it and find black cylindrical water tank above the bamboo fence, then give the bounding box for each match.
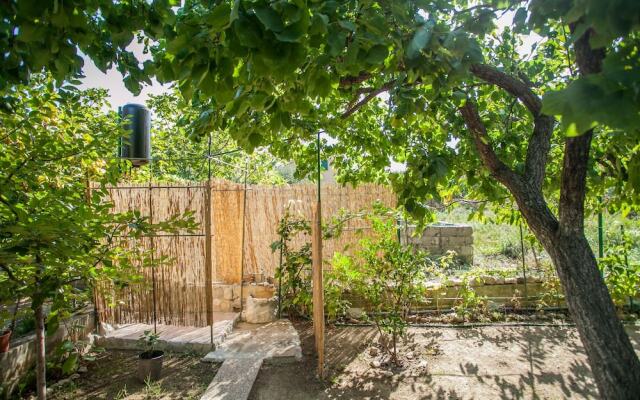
[120,104,151,167]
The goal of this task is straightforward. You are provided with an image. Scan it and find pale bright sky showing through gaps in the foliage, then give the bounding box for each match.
[81,12,540,110]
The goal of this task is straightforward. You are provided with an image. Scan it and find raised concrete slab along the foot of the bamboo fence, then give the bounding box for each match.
[96,312,239,353]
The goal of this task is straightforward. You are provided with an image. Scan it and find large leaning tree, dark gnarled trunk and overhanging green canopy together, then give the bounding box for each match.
[3,0,640,399]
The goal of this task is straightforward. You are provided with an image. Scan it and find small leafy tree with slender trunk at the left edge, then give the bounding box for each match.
[0,76,195,400]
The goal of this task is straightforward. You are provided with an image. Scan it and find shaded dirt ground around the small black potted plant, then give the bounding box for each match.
[50,351,218,400]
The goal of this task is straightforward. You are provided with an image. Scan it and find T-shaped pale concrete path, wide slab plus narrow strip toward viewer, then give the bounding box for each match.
[200,320,302,400]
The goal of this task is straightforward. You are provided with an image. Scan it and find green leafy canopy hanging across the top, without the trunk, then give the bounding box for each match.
[3,0,640,215]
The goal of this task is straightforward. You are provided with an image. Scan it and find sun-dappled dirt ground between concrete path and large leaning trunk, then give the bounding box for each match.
[250,323,640,400]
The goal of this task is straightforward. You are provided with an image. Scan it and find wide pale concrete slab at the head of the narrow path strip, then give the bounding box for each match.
[202,319,302,364]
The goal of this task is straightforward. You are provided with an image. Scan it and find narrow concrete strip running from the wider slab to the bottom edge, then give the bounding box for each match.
[200,357,263,400]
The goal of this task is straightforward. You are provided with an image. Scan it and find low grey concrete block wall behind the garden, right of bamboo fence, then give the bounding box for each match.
[400,222,473,264]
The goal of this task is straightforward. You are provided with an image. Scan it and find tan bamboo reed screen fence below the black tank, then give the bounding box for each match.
[96,180,395,326]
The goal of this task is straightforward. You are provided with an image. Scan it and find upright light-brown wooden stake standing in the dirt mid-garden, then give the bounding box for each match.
[312,202,324,378]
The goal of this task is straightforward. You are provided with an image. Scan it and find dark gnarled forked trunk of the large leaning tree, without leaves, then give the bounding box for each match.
[460,25,640,400]
